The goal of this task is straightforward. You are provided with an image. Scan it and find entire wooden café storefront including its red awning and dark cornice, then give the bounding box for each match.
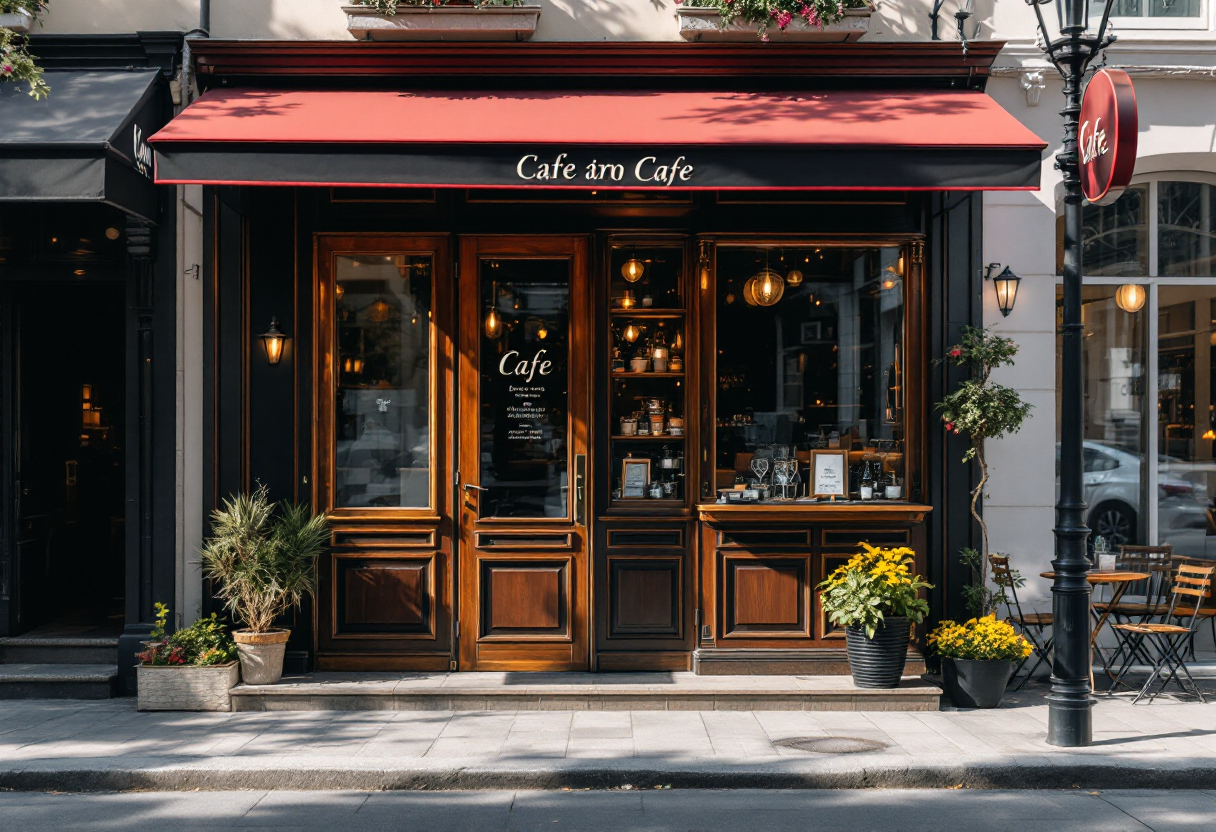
[152,41,1045,673]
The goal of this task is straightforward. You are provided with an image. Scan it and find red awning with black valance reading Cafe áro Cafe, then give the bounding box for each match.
[151,89,1046,190]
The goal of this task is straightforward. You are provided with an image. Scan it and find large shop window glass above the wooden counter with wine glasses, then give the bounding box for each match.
[716,246,907,499]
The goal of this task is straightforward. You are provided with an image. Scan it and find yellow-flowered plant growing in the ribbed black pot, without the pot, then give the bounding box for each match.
[818,543,933,639]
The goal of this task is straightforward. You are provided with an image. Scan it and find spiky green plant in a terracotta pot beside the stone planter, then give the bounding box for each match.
[202,485,330,685]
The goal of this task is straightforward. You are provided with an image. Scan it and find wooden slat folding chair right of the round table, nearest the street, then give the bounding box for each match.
[1110,563,1216,704]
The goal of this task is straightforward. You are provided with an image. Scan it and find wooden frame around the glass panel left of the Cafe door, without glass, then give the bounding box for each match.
[310,234,456,670]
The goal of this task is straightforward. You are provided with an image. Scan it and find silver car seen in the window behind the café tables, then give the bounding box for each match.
[1055,440,1211,550]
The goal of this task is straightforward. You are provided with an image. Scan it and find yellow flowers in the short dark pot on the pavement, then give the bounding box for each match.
[929,614,1031,708]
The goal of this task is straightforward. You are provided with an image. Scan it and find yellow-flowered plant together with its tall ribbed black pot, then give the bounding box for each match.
[818,543,933,687]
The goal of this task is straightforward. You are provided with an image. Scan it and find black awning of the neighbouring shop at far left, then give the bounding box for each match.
[0,69,165,220]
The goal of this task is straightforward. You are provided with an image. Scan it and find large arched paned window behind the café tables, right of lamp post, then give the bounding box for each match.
[1057,180,1216,558]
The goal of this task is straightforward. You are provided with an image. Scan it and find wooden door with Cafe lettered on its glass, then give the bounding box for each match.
[457,237,591,670]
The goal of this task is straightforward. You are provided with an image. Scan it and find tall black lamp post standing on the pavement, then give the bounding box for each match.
[1028,0,1115,747]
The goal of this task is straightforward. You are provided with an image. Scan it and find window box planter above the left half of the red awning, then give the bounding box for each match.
[342,0,540,41]
